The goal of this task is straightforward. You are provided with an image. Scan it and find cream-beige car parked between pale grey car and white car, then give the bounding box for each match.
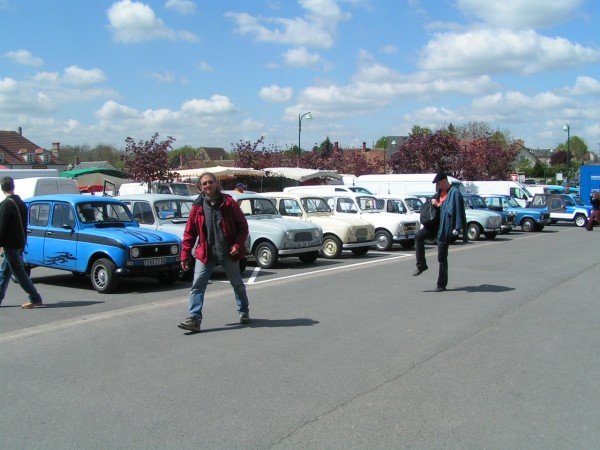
[262,192,375,259]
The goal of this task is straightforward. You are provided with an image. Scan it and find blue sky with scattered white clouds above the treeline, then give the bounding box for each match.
[0,0,600,152]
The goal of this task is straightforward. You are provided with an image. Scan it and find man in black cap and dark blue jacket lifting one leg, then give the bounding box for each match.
[413,172,468,292]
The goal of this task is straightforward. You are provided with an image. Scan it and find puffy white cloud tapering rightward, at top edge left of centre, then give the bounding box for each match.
[106,0,197,43]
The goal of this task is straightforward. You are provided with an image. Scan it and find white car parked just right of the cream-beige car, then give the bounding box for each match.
[316,192,420,251]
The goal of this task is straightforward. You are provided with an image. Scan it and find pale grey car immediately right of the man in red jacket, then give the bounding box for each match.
[227,191,323,269]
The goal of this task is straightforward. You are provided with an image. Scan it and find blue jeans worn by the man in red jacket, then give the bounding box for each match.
[189,257,248,320]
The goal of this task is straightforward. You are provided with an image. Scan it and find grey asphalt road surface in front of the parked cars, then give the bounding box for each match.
[0,225,600,449]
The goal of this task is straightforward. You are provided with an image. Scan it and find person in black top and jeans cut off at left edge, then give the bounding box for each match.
[0,177,44,309]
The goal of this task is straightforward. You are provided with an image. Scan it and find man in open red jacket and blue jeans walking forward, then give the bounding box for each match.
[178,172,250,332]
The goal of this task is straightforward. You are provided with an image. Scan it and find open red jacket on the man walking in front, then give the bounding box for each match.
[181,193,248,263]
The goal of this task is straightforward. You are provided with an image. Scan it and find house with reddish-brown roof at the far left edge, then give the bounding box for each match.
[0,127,66,172]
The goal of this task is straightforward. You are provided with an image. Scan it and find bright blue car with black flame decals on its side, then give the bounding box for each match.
[23,194,181,293]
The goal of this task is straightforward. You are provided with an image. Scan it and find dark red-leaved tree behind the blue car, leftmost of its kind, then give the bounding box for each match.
[123,133,176,185]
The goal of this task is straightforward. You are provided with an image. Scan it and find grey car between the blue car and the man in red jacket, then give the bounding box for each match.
[117,194,250,280]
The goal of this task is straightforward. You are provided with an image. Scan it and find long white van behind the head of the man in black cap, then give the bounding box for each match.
[355,173,464,195]
